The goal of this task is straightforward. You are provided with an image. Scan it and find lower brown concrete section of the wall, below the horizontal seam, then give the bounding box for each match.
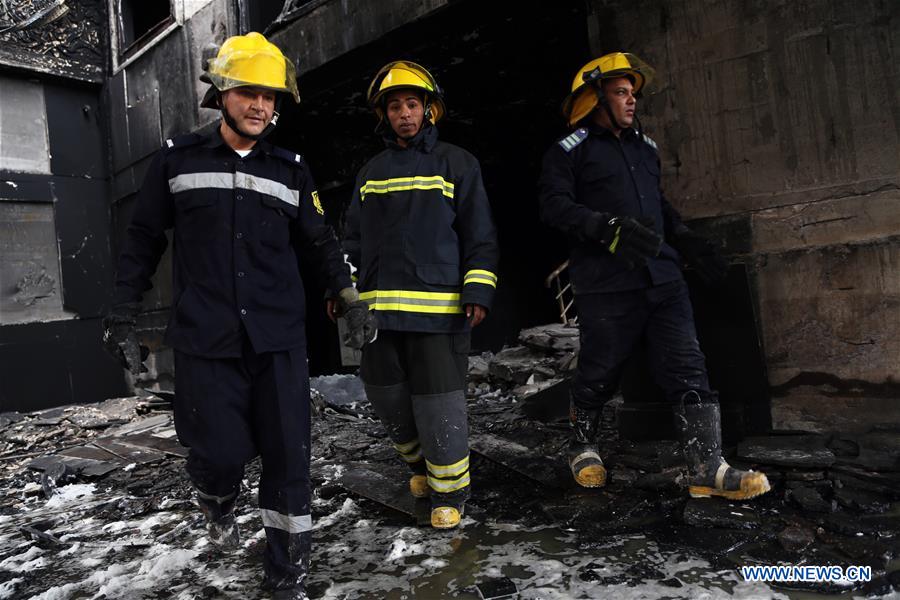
[759,238,900,430]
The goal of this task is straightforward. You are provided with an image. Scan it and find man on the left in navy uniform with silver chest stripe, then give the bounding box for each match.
[104,32,374,598]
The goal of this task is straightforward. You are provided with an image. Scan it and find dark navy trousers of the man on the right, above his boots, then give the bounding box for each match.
[572,280,715,411]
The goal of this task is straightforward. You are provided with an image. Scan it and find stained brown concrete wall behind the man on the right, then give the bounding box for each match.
[589,0,900,430]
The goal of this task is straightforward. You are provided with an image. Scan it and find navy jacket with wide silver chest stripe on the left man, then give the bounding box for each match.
[115,129,351,358]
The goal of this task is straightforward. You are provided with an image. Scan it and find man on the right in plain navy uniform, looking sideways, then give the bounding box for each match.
[539,52,769,499]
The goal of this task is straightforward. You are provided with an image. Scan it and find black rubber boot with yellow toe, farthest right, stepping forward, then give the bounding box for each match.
[675,391,770,500]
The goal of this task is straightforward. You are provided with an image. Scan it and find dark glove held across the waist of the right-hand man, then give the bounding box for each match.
[584,213,662,269]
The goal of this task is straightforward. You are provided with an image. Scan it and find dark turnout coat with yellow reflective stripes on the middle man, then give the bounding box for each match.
[344,124,499,332]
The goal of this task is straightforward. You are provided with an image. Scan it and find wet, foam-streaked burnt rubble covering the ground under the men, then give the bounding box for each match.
[0,325,900,599]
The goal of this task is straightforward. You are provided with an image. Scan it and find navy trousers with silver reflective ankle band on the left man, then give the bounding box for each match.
[175,335,312,589]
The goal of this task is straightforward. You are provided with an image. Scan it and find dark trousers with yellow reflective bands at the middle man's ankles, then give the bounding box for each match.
[360,331,470,509]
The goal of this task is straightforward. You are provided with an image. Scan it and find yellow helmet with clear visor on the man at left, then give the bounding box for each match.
[200,31,300,108]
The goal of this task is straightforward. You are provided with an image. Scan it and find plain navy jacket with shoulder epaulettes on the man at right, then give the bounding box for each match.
[539,124,686,294]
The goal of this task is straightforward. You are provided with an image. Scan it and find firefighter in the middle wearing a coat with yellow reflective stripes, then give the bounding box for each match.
[344,61,498,528]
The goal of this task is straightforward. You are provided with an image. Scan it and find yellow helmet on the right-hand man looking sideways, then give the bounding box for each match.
[562,52,656,127]
